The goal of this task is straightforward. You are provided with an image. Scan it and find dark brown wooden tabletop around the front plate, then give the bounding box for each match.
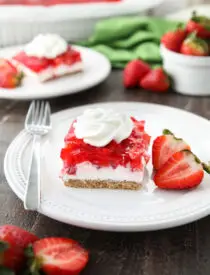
[0,71,210,275]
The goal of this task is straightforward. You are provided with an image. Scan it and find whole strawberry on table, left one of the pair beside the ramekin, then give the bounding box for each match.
[123,60,151,88]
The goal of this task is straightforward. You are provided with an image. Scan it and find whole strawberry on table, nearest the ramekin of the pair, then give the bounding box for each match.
[140,68,170,92]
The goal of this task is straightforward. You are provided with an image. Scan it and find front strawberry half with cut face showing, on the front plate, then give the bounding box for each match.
[153,150,210,189]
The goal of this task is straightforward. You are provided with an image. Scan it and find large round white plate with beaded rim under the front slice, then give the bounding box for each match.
[4,102,210,231]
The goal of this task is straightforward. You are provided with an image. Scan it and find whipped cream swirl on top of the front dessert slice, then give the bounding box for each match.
[74,108,134,147]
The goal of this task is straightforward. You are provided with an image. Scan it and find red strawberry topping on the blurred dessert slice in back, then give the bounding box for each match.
[13,46,82,73]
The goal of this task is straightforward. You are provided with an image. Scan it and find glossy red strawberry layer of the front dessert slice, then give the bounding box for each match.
[61,117,150,174]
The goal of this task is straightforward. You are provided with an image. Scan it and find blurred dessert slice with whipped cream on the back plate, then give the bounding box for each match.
[12,34,83,82]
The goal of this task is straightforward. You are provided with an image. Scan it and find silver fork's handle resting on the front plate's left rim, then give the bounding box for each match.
[24,135,41,210]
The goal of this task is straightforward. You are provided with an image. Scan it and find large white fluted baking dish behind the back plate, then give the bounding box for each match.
[0,0,163,46]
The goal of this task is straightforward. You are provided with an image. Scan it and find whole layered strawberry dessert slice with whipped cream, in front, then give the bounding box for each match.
[61,108,150,190]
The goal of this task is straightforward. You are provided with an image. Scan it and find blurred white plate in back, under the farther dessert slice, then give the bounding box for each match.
[0,46,111,100]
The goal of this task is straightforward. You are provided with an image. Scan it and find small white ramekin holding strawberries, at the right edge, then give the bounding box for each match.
[160,45,210,96]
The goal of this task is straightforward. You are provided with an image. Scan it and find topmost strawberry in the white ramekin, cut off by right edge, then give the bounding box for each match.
[186,12,210,39]
